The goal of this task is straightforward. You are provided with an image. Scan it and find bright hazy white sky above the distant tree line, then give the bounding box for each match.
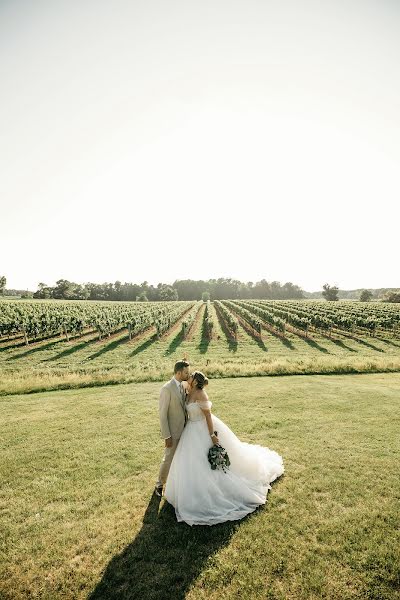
[0,0,400,291]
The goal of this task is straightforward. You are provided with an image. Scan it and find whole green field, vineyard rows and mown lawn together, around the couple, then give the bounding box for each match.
[0,301,400,600]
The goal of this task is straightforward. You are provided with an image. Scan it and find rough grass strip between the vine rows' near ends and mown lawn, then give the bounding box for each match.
[0,305,400,394]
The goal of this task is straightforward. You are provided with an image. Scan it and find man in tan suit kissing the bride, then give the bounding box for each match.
[154,360,189,496]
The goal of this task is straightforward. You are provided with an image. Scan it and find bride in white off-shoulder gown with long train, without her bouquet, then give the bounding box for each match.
[164,371,284,525]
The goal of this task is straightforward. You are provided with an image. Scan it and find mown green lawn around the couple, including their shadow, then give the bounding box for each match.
[0,372,400,600]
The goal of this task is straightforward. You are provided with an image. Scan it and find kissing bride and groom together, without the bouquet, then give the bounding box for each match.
[155,360,284,525]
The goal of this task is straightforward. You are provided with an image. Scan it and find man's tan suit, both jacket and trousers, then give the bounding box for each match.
[157,377,186,486]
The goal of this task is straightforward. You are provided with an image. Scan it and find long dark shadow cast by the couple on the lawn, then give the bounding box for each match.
[88,493,255,600]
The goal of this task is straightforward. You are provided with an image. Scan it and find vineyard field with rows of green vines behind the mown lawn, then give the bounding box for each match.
[0,301,400,394]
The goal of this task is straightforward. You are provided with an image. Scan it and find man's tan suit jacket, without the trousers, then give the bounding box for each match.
[159,378,186,439]
